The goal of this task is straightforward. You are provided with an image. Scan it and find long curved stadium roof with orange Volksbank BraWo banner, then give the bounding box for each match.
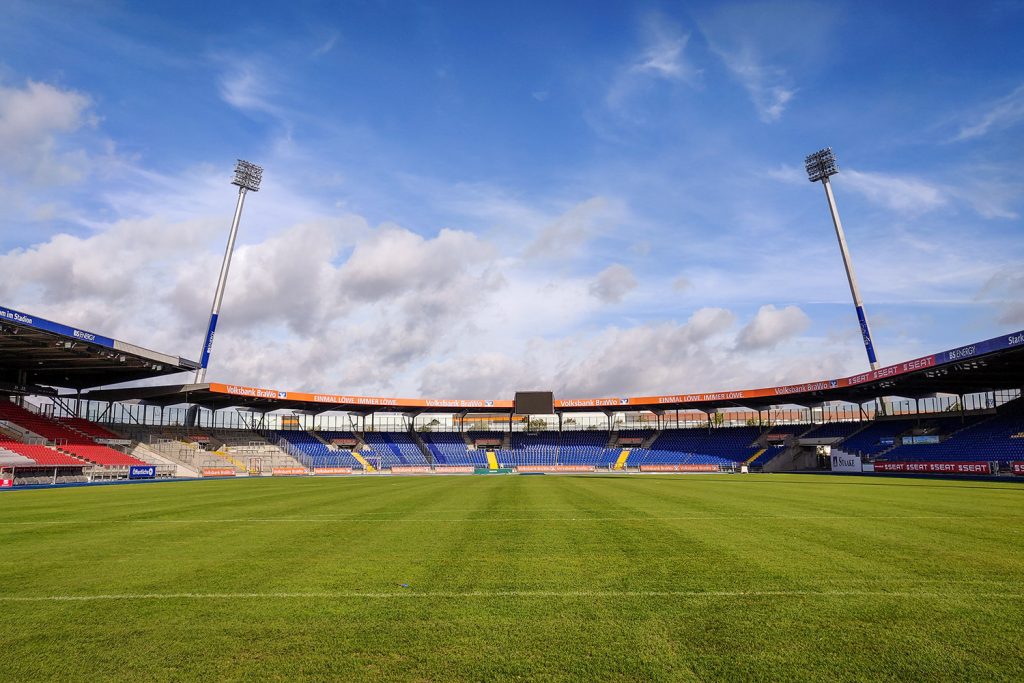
[75,331,1024,414]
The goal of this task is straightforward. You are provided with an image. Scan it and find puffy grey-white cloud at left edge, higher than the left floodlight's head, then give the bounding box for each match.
[0,81,95,184]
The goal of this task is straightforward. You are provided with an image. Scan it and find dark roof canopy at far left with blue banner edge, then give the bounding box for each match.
[0,306,199,394]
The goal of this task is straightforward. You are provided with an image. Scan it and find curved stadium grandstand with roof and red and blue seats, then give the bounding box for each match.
[0,301,1024,485]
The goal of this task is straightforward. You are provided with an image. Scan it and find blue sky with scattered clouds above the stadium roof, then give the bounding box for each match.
[0,0,1024,398]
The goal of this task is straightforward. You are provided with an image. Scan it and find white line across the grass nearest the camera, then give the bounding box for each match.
[0,590,1024,602]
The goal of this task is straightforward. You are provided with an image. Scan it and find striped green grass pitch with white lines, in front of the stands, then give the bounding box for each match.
[0,475,1024,681]
